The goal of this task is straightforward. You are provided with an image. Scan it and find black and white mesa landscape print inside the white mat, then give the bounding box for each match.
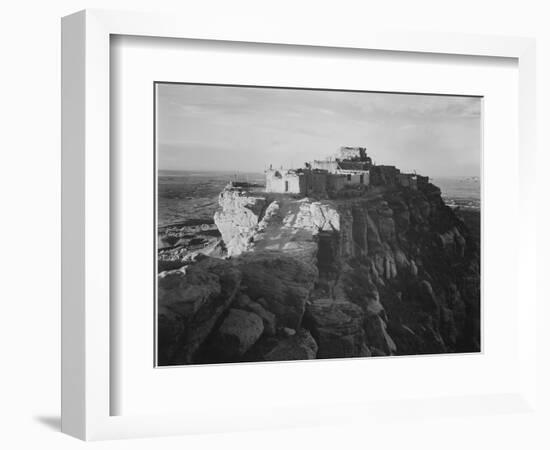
[154,82,483,366]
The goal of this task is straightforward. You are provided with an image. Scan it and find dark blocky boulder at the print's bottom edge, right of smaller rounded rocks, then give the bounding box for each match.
[304,298,369,358]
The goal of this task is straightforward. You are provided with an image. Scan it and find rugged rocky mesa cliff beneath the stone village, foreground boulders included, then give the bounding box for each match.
[158,184,480,365]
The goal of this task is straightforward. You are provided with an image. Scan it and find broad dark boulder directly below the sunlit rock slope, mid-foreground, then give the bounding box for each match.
[235,251,318,329]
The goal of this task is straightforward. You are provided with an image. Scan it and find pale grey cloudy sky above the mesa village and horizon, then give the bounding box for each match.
[157,84,481,177]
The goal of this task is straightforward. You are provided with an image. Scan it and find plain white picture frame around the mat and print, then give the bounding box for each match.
[62,10,537,440]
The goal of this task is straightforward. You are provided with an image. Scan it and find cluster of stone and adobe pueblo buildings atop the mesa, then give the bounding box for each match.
[265,147,429,195]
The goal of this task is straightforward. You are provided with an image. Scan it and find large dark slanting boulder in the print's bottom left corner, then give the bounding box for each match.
[158,257,241,365]
